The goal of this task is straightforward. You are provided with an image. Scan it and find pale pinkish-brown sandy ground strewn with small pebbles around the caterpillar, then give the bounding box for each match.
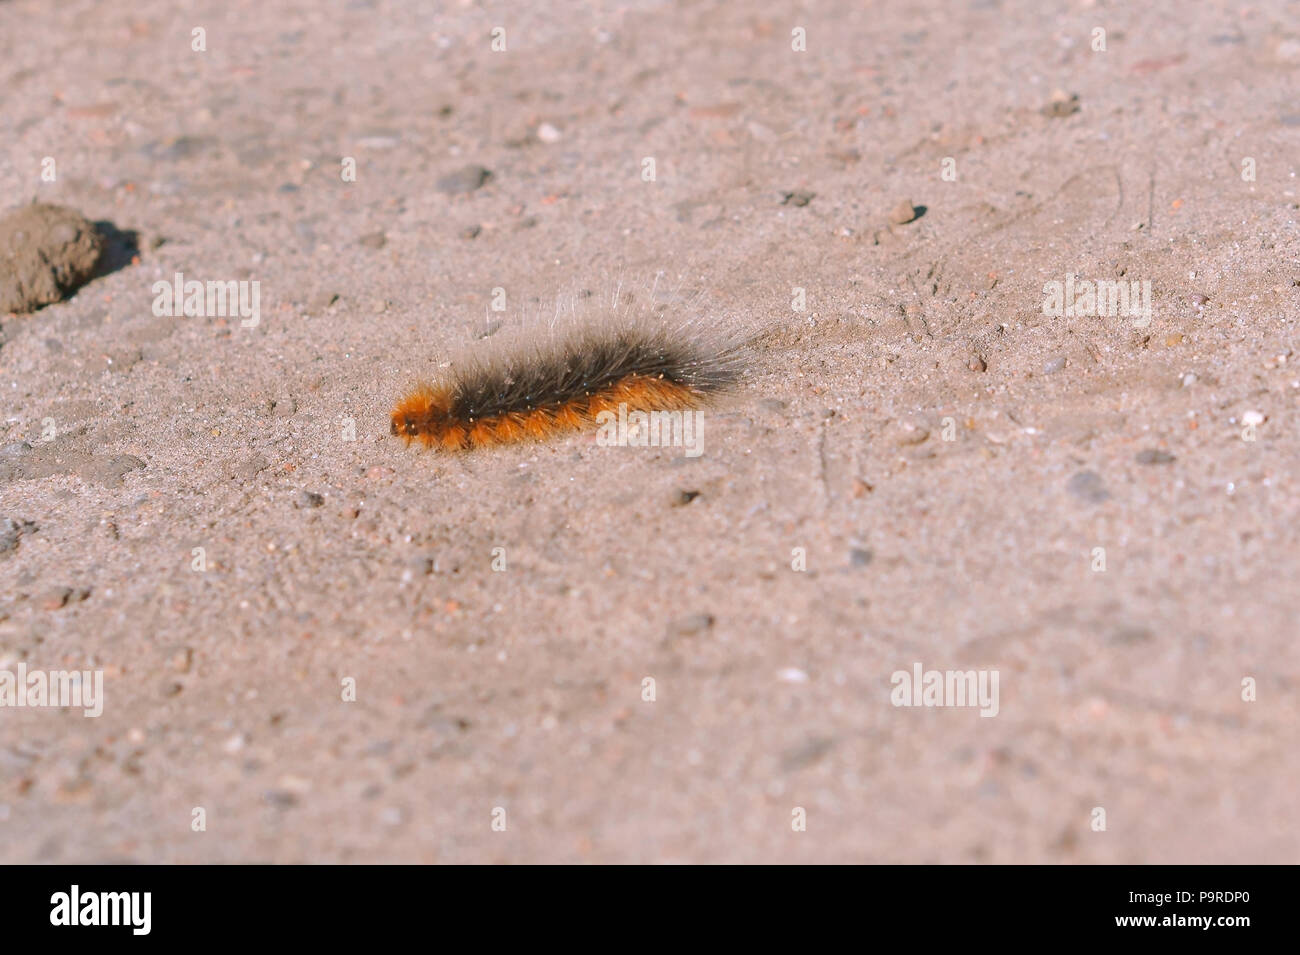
[0,0,1300,863]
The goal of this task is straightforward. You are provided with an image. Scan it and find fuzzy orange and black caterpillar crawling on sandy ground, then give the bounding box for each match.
[391,320,740,451]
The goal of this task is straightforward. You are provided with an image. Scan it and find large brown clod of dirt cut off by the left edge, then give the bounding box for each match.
[0,203,104,312]
